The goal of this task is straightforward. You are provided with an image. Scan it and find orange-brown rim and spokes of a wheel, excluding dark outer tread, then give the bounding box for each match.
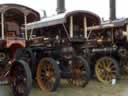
[36,60,55,90]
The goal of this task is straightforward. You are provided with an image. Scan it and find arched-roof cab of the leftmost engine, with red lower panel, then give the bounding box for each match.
[0,4,40,57]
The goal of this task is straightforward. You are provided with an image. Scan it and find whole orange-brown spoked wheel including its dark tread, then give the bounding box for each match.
[36,58,60,91]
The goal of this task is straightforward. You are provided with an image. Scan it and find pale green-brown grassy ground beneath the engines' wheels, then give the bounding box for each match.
[0,80,128,96]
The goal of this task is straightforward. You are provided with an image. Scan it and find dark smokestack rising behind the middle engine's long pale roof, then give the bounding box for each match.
[56,0,65,14]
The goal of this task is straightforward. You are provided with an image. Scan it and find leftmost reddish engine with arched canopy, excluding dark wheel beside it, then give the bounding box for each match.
[0,4,40,95]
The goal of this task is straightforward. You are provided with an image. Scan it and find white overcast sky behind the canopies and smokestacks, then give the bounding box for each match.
[0,0,128,19]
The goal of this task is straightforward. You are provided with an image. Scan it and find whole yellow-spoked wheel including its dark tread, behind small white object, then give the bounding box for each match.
[95,57,119,84]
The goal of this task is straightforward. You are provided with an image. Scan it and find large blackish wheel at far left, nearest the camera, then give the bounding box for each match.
[9,60,32,96]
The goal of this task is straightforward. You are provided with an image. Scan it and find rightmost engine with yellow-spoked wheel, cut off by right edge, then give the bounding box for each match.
[84,19,128,83]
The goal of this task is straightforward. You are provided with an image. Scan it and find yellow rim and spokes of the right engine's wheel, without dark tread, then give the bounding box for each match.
[95,58,116,84]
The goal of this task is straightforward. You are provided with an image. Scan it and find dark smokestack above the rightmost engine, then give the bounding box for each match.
[110,0,116,20]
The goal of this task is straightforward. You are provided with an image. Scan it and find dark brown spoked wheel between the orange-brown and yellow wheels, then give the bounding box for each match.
[68,56,91,87]
